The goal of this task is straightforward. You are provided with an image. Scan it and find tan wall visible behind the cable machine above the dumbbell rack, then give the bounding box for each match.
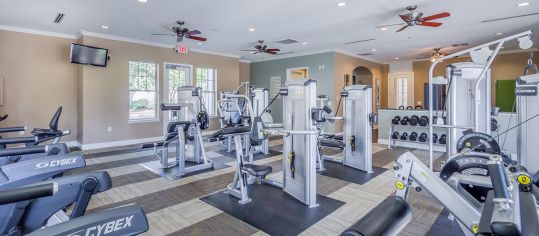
[412,52,539,104]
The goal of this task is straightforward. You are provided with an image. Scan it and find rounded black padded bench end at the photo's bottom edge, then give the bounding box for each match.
[341,196,412,236]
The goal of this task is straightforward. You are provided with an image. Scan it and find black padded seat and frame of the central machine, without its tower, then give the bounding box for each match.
[225,124,273,204]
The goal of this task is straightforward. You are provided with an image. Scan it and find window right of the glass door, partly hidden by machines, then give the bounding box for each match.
[195,68,217,116]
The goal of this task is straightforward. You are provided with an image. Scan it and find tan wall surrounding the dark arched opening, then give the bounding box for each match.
[333,52,387,132]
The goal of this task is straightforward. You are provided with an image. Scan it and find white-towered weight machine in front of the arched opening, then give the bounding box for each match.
[319,85,376,173]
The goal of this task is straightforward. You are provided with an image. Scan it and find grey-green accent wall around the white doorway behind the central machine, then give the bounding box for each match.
[251,52,335,123]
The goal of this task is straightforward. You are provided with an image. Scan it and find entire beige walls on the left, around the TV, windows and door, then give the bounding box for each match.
[0,30,243,147]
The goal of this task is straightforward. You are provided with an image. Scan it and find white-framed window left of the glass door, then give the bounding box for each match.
[129,61,158,121]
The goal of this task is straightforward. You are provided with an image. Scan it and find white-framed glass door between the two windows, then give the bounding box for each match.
[163,63,193,133]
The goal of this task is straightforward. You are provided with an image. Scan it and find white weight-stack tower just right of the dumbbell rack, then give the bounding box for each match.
[447,62,491,156]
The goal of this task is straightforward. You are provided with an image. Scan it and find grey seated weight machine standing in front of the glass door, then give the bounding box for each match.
[149,86,213,178]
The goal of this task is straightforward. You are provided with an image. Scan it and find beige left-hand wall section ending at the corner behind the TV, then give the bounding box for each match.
[0,30,78,141]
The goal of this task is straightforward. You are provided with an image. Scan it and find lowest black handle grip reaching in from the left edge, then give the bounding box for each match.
[0,183,58,205]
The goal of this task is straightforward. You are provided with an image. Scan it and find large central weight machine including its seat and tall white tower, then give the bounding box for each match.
[227,79,322,207]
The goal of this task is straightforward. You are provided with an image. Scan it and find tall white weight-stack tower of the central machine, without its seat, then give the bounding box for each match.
[279,79,321,207]
